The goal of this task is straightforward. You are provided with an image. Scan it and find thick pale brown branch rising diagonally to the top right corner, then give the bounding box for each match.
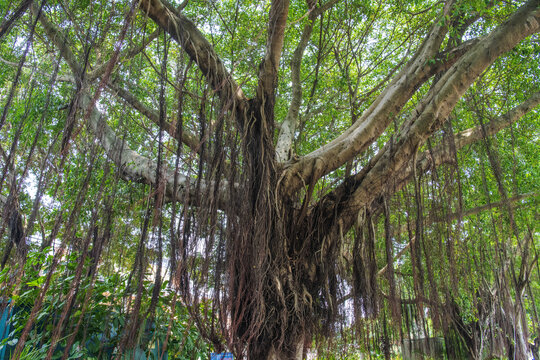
[350,0,540,214]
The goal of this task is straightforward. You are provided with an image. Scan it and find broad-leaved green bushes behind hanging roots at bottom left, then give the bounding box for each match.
[0,248,211,359]
